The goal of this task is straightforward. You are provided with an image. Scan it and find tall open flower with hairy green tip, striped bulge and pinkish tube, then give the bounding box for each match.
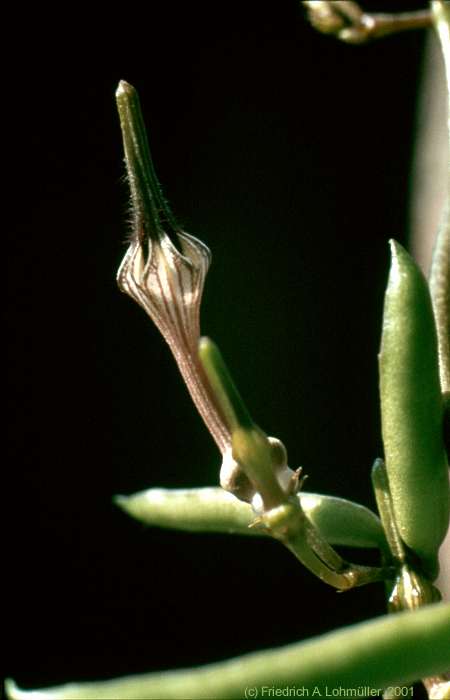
[116,81,292,501]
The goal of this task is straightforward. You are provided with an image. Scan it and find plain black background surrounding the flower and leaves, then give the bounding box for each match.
[4,0,424,687]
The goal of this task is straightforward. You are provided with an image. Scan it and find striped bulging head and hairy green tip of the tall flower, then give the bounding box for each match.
[116,80,211,361]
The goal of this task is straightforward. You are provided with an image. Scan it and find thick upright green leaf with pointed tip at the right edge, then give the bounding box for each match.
[379,241,449,576]
